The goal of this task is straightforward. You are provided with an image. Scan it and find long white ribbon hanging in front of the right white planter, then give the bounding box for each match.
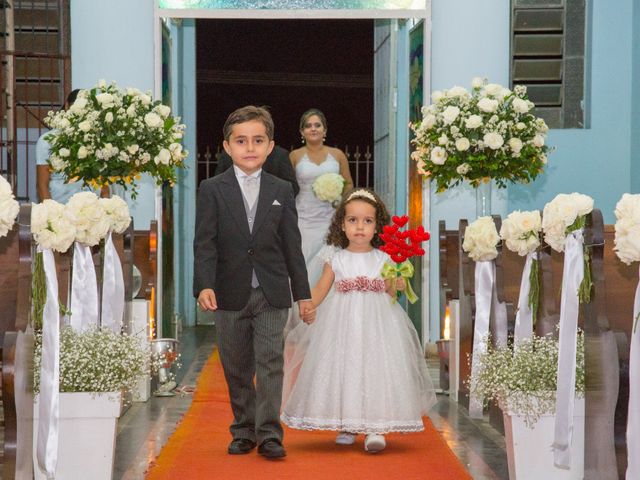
[553,230,584,468]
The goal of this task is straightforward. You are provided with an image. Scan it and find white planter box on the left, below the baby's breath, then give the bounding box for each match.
[33,392,122,480]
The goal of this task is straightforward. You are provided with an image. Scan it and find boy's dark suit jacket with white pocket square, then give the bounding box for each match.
[193,168,311,310]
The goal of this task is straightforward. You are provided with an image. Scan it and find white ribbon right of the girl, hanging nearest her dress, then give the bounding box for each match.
[469,260,496,418]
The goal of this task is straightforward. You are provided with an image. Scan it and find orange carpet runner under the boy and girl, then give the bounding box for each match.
[146,351,471,480]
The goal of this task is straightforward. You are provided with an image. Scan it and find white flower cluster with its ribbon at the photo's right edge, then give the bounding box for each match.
[614,193,640,478]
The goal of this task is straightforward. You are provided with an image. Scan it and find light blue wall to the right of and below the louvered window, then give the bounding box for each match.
[509,0,640,223]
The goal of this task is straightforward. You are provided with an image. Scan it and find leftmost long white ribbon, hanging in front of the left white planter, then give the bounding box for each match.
[36,249,60,478]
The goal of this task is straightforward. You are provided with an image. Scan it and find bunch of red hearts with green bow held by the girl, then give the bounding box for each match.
[380,215,430,303]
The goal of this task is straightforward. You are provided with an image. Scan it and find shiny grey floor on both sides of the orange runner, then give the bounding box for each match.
[113,326,508,480]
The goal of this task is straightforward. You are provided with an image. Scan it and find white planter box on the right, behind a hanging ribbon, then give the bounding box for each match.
[503,398,584,480]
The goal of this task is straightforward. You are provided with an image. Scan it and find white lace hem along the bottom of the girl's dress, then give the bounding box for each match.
[280,413,424,435]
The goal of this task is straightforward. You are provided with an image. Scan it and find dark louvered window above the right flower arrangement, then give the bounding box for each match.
[511,0,587,128]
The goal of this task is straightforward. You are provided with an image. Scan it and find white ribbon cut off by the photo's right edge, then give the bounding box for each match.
[627,266,640,480]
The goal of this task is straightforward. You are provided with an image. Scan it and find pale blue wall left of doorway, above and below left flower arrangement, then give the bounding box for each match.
[71,0,155,229]
